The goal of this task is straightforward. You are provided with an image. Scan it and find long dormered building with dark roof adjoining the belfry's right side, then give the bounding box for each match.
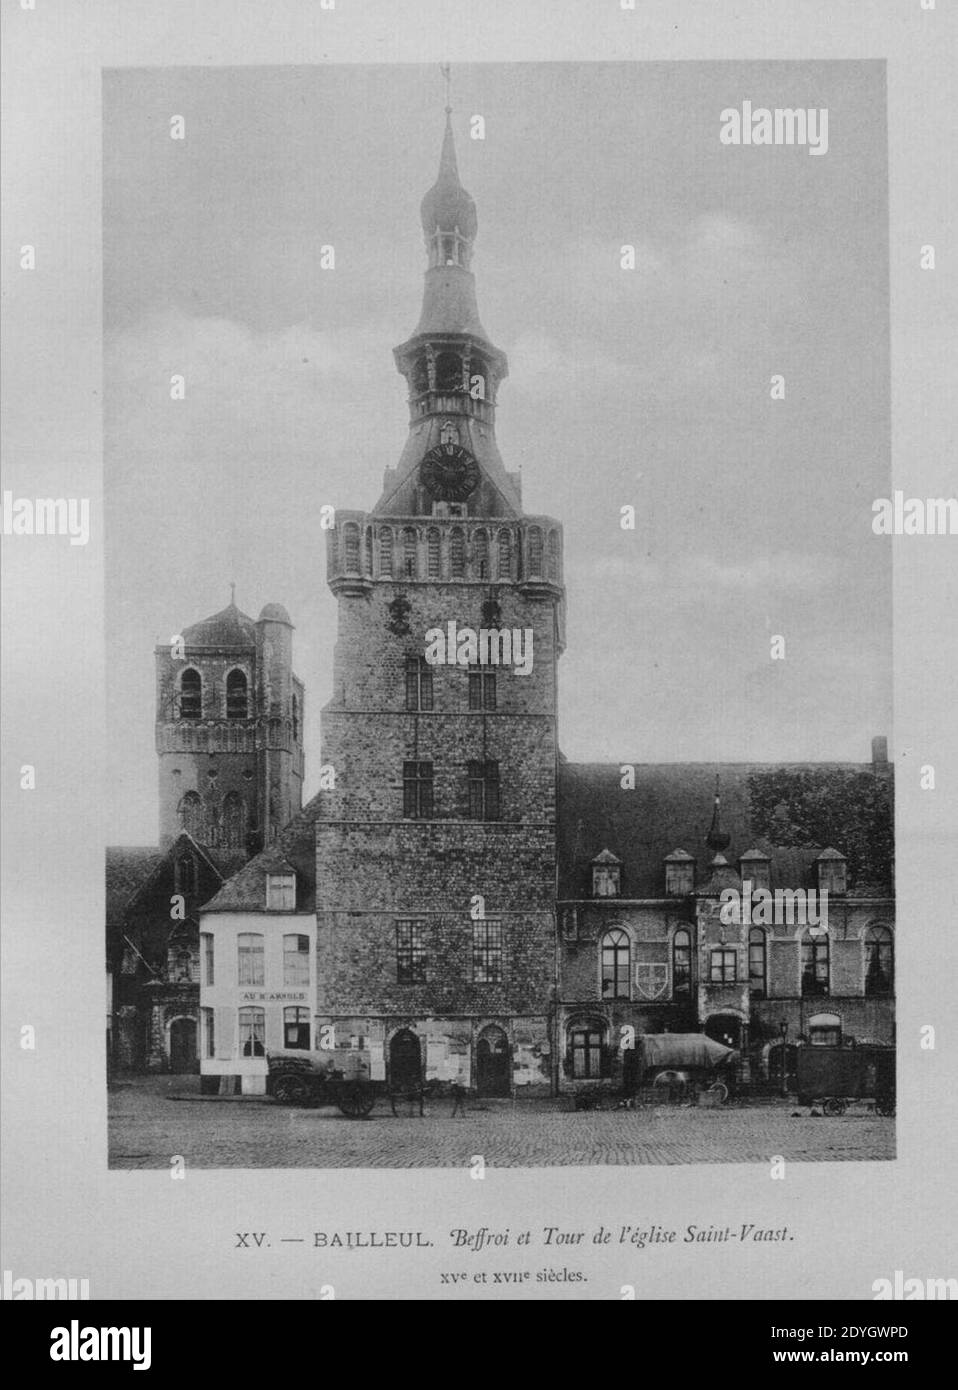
[558,759,895,1090]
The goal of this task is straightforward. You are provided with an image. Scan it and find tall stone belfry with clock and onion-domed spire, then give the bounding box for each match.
[317,97,565,1094]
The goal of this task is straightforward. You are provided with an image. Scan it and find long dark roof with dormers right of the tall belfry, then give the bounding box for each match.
[558,759,893,899]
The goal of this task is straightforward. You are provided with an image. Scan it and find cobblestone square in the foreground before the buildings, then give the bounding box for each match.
[110,1077,895,1168]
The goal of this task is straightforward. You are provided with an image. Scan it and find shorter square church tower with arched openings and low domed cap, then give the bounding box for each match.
[156,600,303,859]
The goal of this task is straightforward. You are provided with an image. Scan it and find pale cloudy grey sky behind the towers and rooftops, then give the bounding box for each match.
[103,61,893,844]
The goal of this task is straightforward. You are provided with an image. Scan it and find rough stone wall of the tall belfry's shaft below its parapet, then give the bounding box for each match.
[316,536,560,1087]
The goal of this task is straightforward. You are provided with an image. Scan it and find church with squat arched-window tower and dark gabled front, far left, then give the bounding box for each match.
[106,603,305,1072]
